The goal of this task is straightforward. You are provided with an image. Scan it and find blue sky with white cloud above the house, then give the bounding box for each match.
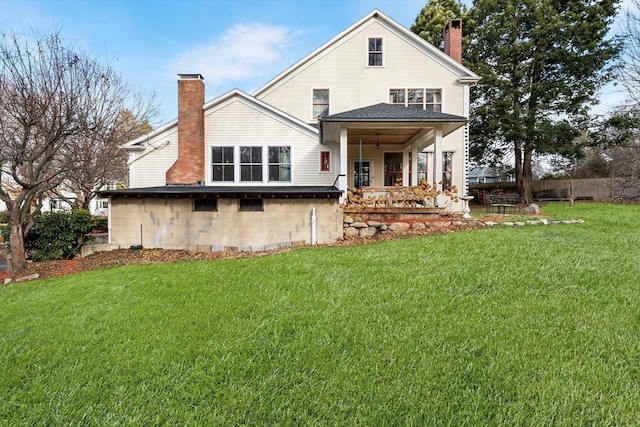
[0,0,628,125]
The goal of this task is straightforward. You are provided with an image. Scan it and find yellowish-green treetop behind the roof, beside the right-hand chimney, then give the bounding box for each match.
[411,0,466,48]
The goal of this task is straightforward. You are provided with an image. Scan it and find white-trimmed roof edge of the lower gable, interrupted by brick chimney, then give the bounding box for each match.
[122,89,318,151]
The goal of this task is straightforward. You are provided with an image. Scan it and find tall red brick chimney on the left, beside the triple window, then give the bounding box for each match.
[166,74,205,185]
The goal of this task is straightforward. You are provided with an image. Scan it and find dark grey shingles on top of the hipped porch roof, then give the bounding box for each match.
[321,103,468,123]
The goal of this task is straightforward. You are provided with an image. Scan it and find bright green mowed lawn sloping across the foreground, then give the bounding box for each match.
[0,203,640,426]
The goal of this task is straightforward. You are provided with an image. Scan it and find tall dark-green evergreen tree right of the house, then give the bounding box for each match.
[466,0,621,203]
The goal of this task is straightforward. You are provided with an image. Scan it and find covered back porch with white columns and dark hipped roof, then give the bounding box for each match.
[320,103,468,208]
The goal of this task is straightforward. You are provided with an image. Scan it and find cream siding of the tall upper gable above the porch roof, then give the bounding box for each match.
[256,21,465,122]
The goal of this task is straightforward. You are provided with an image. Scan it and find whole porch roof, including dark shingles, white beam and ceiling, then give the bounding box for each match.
[320,103,469,143]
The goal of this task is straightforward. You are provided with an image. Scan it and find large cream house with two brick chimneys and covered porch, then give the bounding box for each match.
[100,10,479,251]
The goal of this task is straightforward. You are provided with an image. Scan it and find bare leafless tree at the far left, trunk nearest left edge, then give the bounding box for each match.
[0,28,154,271]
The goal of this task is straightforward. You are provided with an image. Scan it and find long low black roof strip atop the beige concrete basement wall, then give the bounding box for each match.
[98,185,342,199]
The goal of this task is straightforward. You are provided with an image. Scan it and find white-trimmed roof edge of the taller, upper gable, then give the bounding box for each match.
[252,9,480,97]
